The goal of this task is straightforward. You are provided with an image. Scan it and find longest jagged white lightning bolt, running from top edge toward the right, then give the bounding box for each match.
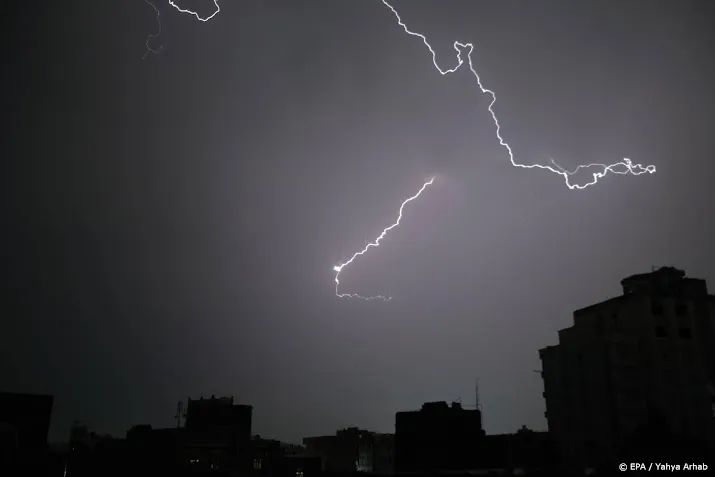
[381,0,655,190]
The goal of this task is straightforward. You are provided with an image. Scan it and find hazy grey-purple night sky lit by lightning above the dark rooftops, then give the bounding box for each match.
[5,0,715,442]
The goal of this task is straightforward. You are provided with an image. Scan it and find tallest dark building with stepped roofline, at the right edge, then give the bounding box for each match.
[539,267,715,471]
